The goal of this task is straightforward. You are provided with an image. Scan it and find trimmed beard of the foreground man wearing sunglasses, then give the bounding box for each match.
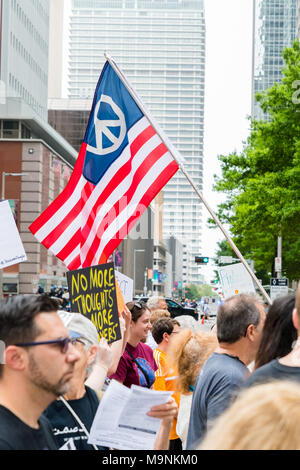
[29,354,72,397]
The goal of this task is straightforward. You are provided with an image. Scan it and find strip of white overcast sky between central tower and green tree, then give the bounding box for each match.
[202,0,253,280]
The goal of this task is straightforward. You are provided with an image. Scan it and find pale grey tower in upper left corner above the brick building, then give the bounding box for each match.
[0,0,49,121]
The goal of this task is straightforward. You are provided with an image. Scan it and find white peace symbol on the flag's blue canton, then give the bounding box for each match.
[87,95,126,155]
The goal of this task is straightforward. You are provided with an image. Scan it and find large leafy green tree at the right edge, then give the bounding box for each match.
[214,40,300,279]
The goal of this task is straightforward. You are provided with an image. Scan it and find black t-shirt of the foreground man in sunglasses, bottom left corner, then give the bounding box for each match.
[0,405,58,450]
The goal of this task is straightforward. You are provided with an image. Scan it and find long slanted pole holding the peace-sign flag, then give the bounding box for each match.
[104,53,272,305]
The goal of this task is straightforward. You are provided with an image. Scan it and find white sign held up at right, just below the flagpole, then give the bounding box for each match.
[218,263,255,299]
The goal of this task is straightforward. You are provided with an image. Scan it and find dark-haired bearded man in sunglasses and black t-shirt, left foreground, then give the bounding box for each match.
[0,295,80,450]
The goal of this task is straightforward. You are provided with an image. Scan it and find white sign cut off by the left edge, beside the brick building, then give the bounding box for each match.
[0,201,27,269]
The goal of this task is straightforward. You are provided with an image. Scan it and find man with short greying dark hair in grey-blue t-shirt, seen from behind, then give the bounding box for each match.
[187,294,265,450]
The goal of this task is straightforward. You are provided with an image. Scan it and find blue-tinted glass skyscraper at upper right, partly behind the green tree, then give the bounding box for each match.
[252,0,297,119]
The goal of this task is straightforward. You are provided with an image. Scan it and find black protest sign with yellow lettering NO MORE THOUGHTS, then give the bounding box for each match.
[67,263,121,343]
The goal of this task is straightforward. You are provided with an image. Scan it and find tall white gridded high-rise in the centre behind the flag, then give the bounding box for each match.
[68,0,205,283]
